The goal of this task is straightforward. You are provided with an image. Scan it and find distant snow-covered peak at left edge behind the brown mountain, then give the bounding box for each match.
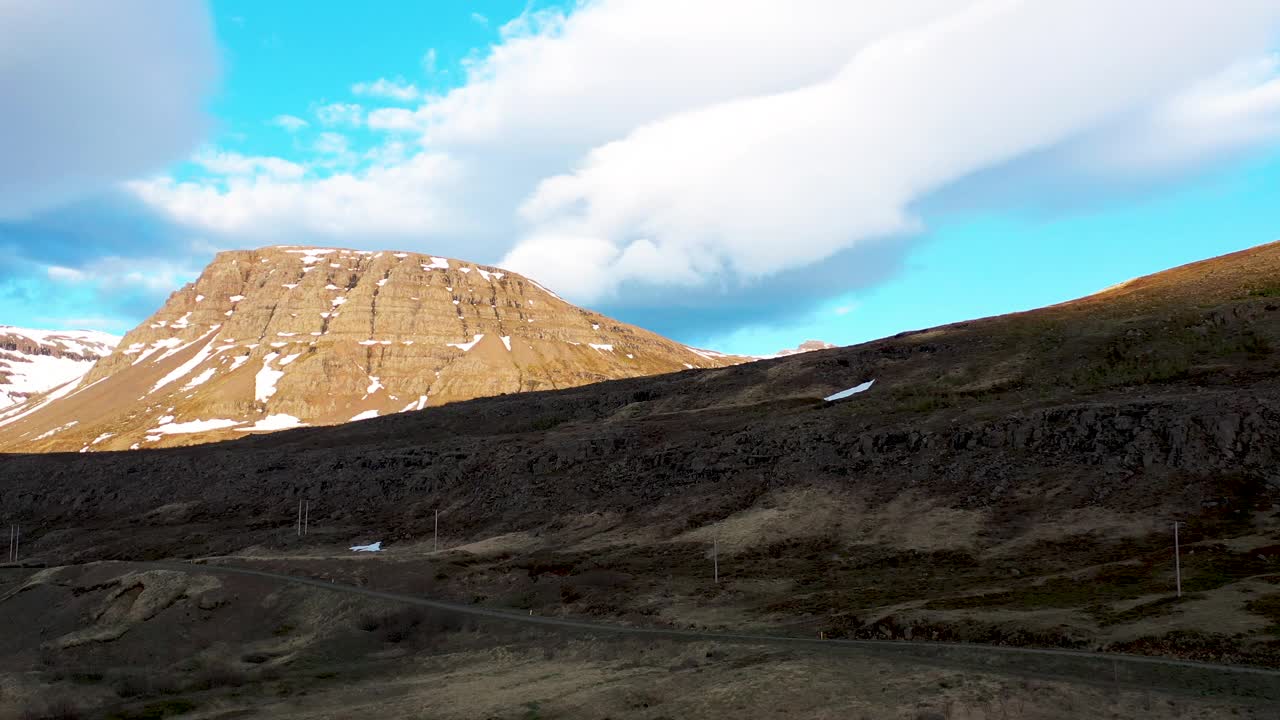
[0,325,120,409]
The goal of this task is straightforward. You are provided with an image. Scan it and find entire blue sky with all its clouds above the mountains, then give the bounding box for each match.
[0,0,1280,354]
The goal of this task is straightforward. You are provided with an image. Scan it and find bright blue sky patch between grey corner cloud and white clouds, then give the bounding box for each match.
[200,0,540,163]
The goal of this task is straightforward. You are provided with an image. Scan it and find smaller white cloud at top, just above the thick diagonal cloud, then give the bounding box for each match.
[426,0,955,148]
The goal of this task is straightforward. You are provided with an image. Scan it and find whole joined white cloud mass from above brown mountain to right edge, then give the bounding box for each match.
[127,0,1280,308]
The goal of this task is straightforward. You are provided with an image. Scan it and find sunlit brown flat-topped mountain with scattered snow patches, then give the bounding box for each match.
[0,247,737,451]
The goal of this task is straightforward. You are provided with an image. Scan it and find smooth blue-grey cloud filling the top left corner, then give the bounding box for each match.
[0,0,218,219]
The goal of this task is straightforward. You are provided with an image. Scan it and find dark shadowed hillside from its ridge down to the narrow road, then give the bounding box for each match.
[0,239,1280,666]
